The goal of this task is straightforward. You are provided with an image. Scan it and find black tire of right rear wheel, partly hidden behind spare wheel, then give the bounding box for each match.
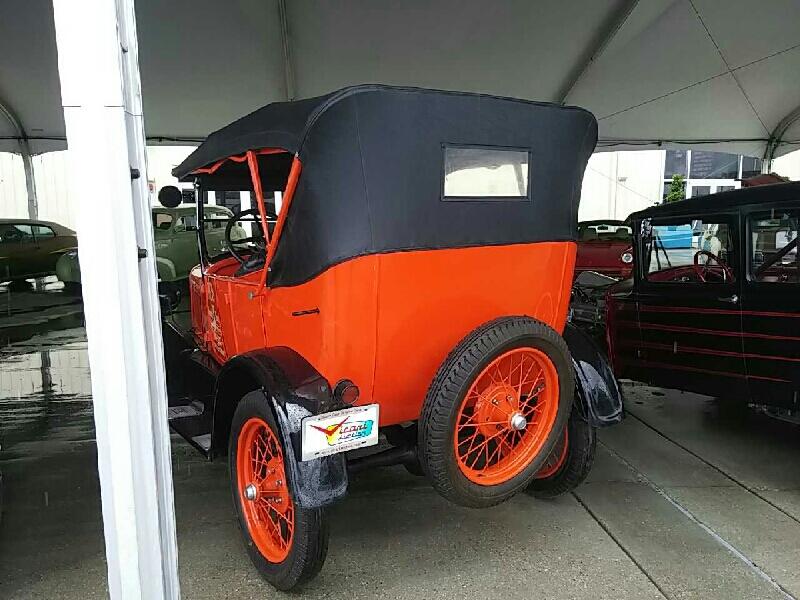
[525,410,597,498]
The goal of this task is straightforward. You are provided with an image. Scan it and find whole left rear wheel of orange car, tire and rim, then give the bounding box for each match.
[228,391,328,590]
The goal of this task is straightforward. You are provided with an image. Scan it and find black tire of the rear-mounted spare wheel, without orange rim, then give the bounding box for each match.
[418,317,575,508]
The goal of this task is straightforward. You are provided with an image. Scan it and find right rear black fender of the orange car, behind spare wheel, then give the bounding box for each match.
[563,323,625,427]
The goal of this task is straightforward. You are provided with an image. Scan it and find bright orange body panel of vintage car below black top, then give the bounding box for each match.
[190,242,576,426]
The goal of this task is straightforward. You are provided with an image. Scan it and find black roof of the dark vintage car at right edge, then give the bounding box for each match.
[628,181,800,220]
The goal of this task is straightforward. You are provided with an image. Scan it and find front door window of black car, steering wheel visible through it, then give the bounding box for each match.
[643,219,735,283]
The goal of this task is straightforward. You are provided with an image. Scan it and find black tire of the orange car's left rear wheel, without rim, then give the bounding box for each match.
[228,391,329,591]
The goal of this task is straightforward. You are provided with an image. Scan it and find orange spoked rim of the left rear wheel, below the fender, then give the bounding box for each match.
[236,417,294,563]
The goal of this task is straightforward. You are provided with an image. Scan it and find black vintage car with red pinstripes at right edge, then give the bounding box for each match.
[606,183,800,422]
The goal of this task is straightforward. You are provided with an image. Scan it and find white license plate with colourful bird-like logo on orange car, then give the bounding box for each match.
[302,404,378,460]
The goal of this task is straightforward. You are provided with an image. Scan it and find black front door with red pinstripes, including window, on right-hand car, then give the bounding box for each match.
[633,214,746,397]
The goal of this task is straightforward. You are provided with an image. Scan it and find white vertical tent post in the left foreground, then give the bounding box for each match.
[53,0,180,600]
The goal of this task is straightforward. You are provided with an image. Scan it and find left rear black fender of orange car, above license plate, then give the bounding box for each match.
[211,346,348,508]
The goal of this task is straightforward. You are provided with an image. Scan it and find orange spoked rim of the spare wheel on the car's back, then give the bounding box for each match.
[453,347,559,485]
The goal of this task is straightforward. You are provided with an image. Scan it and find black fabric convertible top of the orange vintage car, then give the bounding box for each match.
[173,85,597,286]
